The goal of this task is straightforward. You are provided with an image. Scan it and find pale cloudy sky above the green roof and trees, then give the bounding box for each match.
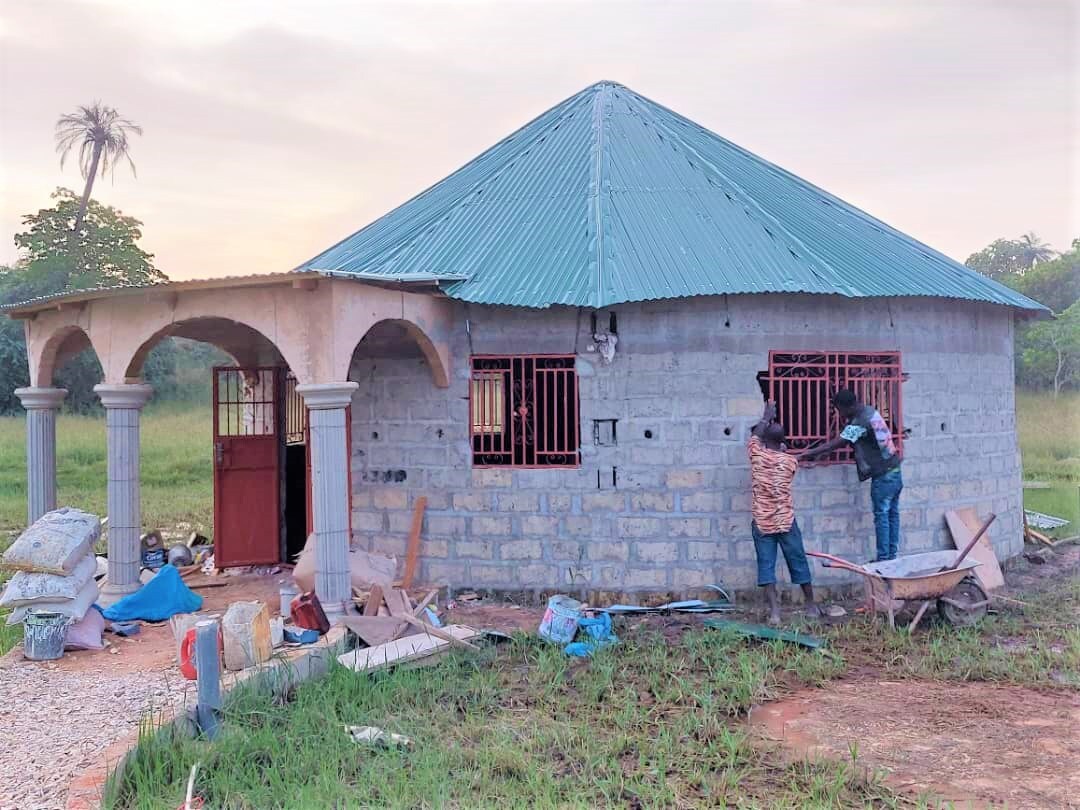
[0,0,1080,279]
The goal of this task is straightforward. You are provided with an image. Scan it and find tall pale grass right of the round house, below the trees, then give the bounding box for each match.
[1016,391,1080,491]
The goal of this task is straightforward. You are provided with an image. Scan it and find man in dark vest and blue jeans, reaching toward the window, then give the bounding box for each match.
[799,389,904,561]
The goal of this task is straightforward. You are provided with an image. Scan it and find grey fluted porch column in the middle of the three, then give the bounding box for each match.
[94,384,153,605]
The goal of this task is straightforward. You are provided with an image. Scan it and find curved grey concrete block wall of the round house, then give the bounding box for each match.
[350,295,1023,593]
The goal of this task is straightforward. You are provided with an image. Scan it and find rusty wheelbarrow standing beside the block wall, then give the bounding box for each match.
[807,515,996,632]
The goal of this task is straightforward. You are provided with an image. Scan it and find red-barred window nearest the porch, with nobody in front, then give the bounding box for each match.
[469,354,581,467]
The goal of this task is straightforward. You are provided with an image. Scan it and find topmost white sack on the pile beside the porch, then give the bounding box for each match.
[0,508,102,575]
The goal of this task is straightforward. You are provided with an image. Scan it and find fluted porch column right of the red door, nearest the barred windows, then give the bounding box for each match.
[296,382,360,615]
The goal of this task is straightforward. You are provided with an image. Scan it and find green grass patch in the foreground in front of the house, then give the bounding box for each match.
[105,630,928,810]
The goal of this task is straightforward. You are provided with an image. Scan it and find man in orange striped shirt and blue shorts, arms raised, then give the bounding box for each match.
[746,402,821,625]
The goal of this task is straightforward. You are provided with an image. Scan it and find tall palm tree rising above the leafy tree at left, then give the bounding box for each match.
[56,102,143,233]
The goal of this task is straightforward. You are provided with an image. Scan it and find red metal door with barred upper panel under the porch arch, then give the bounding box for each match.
[214,367,282,568]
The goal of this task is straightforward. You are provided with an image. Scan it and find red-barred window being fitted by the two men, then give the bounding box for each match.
[761,351,904,463]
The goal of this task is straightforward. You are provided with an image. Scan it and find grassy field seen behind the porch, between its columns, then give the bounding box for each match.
[0,404,214,535]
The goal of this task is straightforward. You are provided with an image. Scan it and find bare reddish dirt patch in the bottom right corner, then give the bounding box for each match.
[751,679,1080,810]
